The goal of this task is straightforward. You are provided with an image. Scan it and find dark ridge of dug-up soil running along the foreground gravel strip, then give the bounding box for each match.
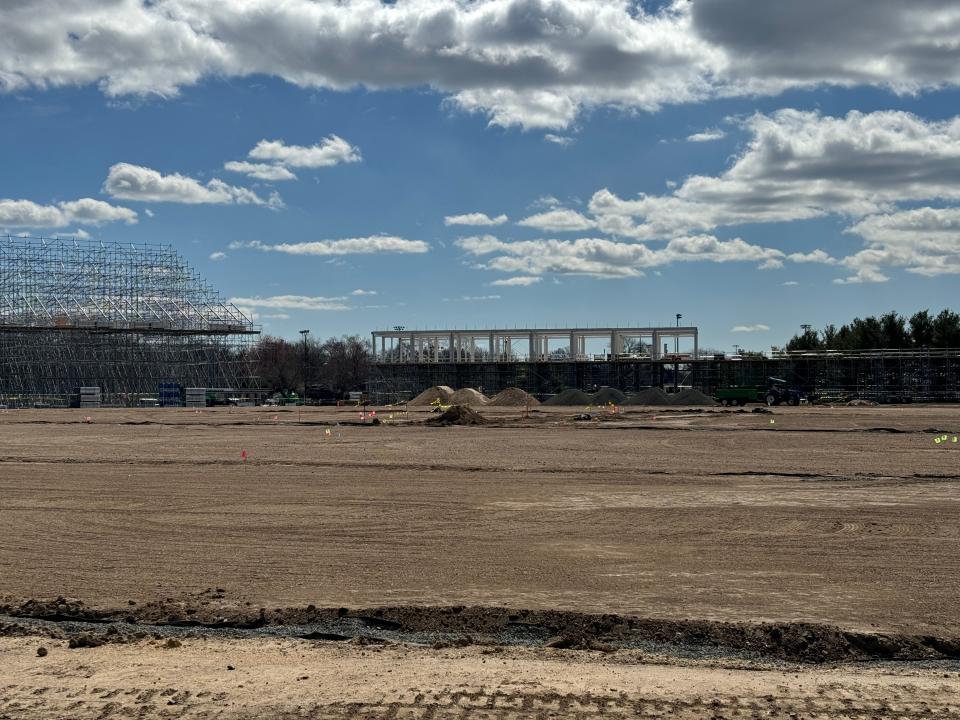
[0,591,960,663]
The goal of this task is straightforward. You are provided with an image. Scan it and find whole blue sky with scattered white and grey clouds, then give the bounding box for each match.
[0,0,960,351]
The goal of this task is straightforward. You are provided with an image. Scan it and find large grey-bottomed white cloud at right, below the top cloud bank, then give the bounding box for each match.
[590,110,960,240]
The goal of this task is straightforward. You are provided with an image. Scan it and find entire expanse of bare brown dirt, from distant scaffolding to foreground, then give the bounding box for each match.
[0,406,960,718]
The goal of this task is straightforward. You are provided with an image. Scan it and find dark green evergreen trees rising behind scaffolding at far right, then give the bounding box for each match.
[786,309,960,350]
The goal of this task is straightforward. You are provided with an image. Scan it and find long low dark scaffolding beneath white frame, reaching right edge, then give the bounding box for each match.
[368,350,960,402]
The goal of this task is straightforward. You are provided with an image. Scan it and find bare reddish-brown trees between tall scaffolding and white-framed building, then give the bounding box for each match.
[249,335,370,399]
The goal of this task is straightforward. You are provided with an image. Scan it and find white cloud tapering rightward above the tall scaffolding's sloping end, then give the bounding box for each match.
[103,163,283,208]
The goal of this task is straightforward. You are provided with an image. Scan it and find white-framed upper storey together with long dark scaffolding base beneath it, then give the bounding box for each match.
[369,327,960,402]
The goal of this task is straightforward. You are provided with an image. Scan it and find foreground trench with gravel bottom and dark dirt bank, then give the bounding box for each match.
[0,590,960,668]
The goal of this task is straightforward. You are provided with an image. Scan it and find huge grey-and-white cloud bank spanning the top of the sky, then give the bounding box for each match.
[0,0,960,129]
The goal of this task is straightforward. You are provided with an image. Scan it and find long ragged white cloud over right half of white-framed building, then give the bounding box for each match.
[456,235,783,278]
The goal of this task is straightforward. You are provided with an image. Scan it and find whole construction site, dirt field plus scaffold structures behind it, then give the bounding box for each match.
[0,242,960,720]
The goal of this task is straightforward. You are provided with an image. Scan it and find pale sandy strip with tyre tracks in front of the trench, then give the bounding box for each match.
[0,638,960,720]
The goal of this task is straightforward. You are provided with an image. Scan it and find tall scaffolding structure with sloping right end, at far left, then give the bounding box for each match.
[0,236,259,407]
